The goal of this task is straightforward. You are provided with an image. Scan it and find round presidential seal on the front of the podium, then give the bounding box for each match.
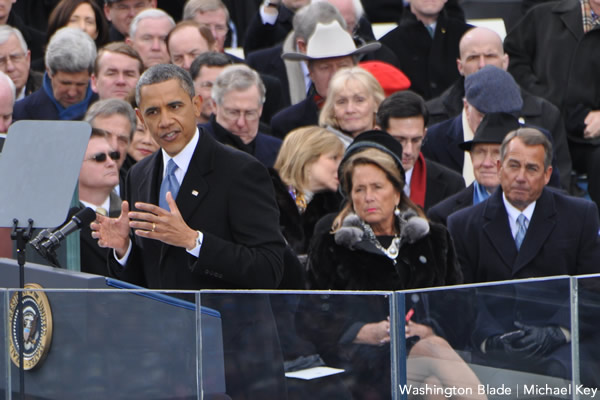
[9,283,52,370]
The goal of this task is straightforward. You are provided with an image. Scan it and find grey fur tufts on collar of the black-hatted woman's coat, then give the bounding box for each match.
[334,209,429,250]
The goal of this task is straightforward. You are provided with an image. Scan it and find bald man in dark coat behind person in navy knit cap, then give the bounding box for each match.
[427,27,572,190]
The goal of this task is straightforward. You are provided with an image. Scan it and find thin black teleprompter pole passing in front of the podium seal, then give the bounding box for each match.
[10,218,33,400]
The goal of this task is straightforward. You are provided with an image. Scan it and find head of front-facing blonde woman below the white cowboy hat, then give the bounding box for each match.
[319,67,385,147]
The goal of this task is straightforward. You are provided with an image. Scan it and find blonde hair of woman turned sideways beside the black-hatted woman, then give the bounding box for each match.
[273,126,344,192]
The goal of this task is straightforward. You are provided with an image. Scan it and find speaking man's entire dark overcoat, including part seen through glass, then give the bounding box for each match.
[109,130,285,399]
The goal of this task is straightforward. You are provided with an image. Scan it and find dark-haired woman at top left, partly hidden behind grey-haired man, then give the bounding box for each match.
[46,0,108,49]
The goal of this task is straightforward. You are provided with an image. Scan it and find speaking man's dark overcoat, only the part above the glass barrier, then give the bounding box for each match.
[112,131,284,290]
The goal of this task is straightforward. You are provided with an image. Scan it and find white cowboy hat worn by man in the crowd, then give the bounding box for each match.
[281,20,381,61]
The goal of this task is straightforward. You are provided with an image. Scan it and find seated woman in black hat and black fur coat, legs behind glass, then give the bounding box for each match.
[302,131,485,399]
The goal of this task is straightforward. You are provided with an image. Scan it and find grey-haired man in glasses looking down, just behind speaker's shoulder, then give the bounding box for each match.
[201,64,281,167]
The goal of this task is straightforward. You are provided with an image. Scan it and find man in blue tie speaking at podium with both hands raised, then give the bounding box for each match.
[92,64,285,399]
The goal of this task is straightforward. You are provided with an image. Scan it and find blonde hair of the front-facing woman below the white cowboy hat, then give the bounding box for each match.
[319,67,385,129]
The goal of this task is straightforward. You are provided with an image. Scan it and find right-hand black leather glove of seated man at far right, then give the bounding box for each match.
[512,322,567,358]
